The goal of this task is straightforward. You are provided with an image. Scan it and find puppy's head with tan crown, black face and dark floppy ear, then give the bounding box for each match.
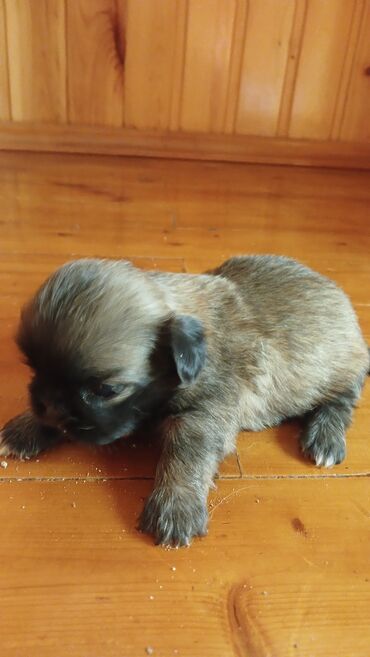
[17,260,205,444]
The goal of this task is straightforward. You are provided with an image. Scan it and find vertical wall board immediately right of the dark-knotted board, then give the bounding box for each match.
[125,0,186,129]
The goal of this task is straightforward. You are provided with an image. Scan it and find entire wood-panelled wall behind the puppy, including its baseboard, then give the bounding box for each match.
[0,0,370,168]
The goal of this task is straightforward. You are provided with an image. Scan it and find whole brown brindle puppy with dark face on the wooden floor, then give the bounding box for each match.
[0,256,369,545]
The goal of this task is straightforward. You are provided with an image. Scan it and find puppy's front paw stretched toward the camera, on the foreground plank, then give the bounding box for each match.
[139,488,208,547]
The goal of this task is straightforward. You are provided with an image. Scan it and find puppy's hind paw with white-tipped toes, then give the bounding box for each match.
[301,432,346,468]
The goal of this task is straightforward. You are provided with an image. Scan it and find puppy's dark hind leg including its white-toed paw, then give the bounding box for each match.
[300,379,363,468]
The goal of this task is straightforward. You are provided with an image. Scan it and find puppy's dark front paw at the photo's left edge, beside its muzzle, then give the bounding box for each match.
[0,412,59,459]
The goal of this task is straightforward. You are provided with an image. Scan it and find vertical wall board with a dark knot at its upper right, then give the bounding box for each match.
[67,0,124,126]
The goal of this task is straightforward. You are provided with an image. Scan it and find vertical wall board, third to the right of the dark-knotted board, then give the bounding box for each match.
[236,0,295,136]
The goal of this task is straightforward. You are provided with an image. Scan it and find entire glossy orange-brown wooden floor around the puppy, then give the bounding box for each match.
[0,153,370,657]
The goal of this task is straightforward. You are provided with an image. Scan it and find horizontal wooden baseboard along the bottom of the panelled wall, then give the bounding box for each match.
[0,122,370,169]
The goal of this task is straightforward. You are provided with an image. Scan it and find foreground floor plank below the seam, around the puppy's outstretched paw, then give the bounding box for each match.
[0,478,370,657]
